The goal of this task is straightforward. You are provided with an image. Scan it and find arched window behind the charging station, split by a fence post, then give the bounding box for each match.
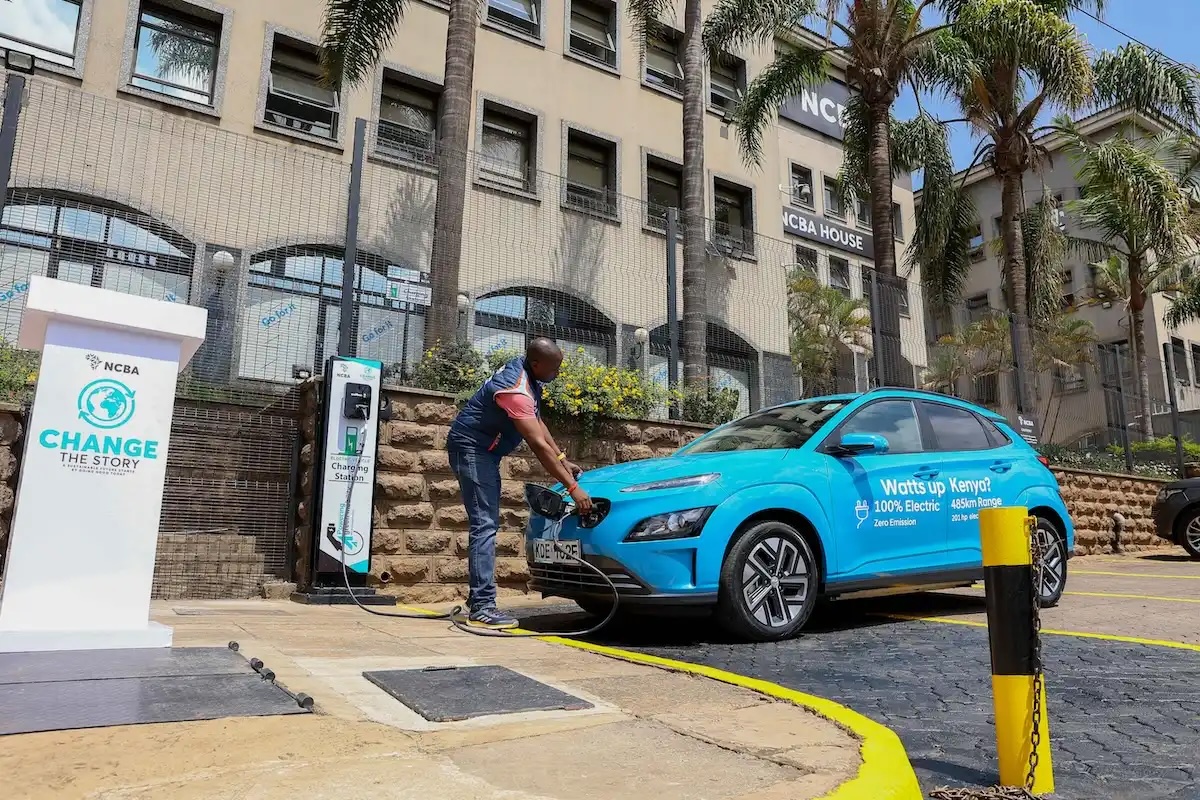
[239,245,430,381]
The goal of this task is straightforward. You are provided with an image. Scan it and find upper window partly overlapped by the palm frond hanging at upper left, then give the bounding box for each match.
[263,35,341,139]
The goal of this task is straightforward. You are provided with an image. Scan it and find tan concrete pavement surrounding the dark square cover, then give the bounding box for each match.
[0,601,860,800]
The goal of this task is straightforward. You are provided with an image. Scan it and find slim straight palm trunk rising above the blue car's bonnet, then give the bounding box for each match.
[680,0,708,386]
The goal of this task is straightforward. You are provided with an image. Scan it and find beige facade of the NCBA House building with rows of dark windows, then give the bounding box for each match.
[0,0,926,410]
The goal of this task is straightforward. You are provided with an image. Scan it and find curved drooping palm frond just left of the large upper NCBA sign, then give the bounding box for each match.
[733,47,829,167]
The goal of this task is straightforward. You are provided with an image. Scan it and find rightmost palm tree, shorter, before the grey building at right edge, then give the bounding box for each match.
[1041,118,1200,437]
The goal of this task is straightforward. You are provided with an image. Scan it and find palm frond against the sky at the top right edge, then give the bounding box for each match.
[1094,43,1200,126]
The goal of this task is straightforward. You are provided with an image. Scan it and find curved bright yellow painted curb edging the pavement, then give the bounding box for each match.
[536,636,924,800]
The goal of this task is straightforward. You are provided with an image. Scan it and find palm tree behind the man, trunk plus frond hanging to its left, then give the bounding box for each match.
[322,0,480,344]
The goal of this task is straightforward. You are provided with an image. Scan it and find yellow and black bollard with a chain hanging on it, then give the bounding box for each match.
[979,507,1054,794]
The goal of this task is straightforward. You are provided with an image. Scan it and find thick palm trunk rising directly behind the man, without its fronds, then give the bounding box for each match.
[425,0,479,347]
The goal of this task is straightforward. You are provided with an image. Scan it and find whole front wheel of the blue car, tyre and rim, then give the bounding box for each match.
[716,519,821,642]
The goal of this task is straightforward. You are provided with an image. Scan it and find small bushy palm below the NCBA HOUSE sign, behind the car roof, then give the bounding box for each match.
[787,267,871,395]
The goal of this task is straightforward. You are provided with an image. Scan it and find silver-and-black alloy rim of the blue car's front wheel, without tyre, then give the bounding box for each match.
[742,536,810,627]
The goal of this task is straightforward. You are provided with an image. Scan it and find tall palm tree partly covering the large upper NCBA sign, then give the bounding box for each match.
[704,0,965,385]
